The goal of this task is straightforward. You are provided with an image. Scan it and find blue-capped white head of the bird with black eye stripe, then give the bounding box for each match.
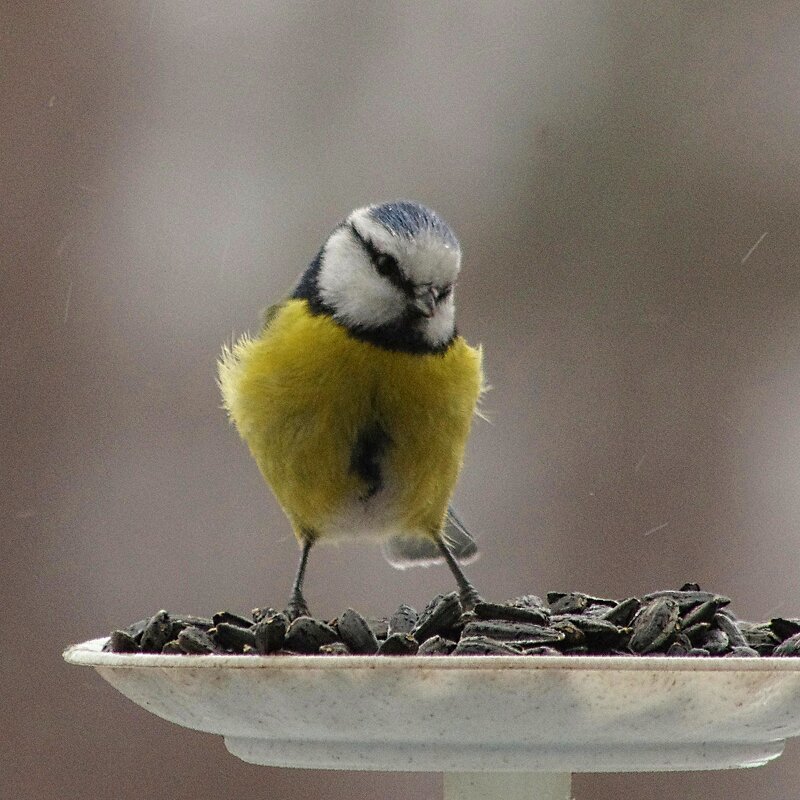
[304,201,461,350]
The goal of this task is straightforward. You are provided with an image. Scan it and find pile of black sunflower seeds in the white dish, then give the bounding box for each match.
[103,583,800,657]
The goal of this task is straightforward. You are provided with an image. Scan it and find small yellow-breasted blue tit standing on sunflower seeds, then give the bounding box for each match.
[218,200,484,619]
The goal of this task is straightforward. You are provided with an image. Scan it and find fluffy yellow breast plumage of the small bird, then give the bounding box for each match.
[219,300,482,537]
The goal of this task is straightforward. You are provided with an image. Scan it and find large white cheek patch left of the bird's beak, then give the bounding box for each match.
[317,228,406,327]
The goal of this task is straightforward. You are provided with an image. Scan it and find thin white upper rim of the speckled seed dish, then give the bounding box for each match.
[63,636,800,672]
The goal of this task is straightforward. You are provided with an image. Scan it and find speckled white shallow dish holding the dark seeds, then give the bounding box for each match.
[64,639,800,772]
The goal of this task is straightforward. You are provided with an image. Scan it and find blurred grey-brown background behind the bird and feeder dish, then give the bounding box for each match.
[0,1,800,800]
